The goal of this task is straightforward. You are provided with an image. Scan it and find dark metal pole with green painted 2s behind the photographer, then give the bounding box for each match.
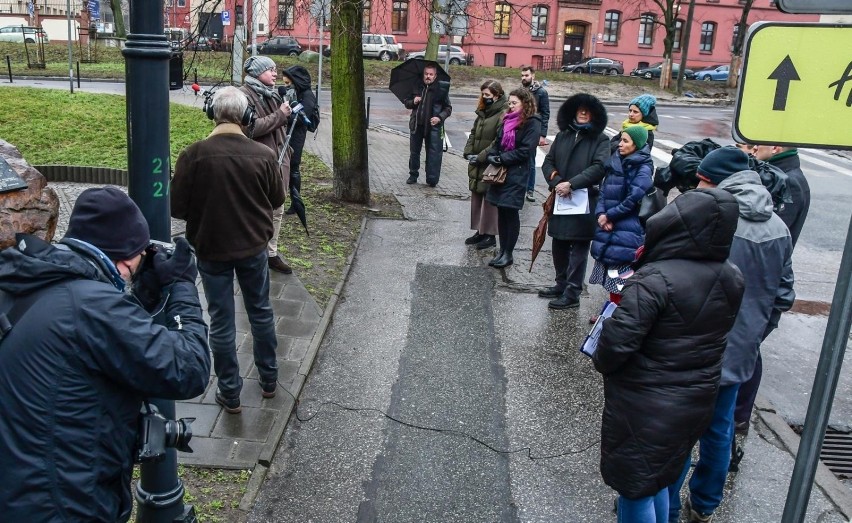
[122,0,195,523]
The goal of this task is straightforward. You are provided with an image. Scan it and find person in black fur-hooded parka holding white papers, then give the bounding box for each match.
[538,93,609,309]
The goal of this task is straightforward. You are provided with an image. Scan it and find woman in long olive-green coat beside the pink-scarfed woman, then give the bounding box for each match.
[464,80,506,249]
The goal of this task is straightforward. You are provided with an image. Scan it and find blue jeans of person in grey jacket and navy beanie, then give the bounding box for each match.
[669,383,740,523]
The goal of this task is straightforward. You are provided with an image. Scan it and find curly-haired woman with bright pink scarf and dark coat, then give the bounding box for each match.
[485,89,541,269]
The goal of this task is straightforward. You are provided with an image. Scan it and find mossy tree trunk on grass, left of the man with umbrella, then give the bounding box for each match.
[331,0,370,204]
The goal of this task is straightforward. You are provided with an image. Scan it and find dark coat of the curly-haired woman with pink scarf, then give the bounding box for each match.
[485,114,541,209]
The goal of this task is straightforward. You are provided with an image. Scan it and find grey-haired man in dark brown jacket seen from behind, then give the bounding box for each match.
[171,87,285,414]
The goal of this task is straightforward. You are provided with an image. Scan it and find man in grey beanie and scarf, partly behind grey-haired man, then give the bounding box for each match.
[240,55,293,274]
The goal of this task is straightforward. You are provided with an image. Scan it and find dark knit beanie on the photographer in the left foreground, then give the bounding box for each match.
[65,186,151,261]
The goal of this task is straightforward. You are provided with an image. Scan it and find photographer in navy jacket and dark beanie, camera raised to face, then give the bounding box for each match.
[0,187,210,522]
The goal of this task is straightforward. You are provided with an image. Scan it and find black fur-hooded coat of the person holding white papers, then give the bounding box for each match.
[541,93,609,241]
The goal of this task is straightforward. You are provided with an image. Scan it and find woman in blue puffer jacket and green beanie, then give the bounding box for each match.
[589,125,654,310]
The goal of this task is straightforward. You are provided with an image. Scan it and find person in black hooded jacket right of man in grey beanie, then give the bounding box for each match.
[281,65,318,214]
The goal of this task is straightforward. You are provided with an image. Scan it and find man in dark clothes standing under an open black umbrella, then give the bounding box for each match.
[391,59,453,187]
